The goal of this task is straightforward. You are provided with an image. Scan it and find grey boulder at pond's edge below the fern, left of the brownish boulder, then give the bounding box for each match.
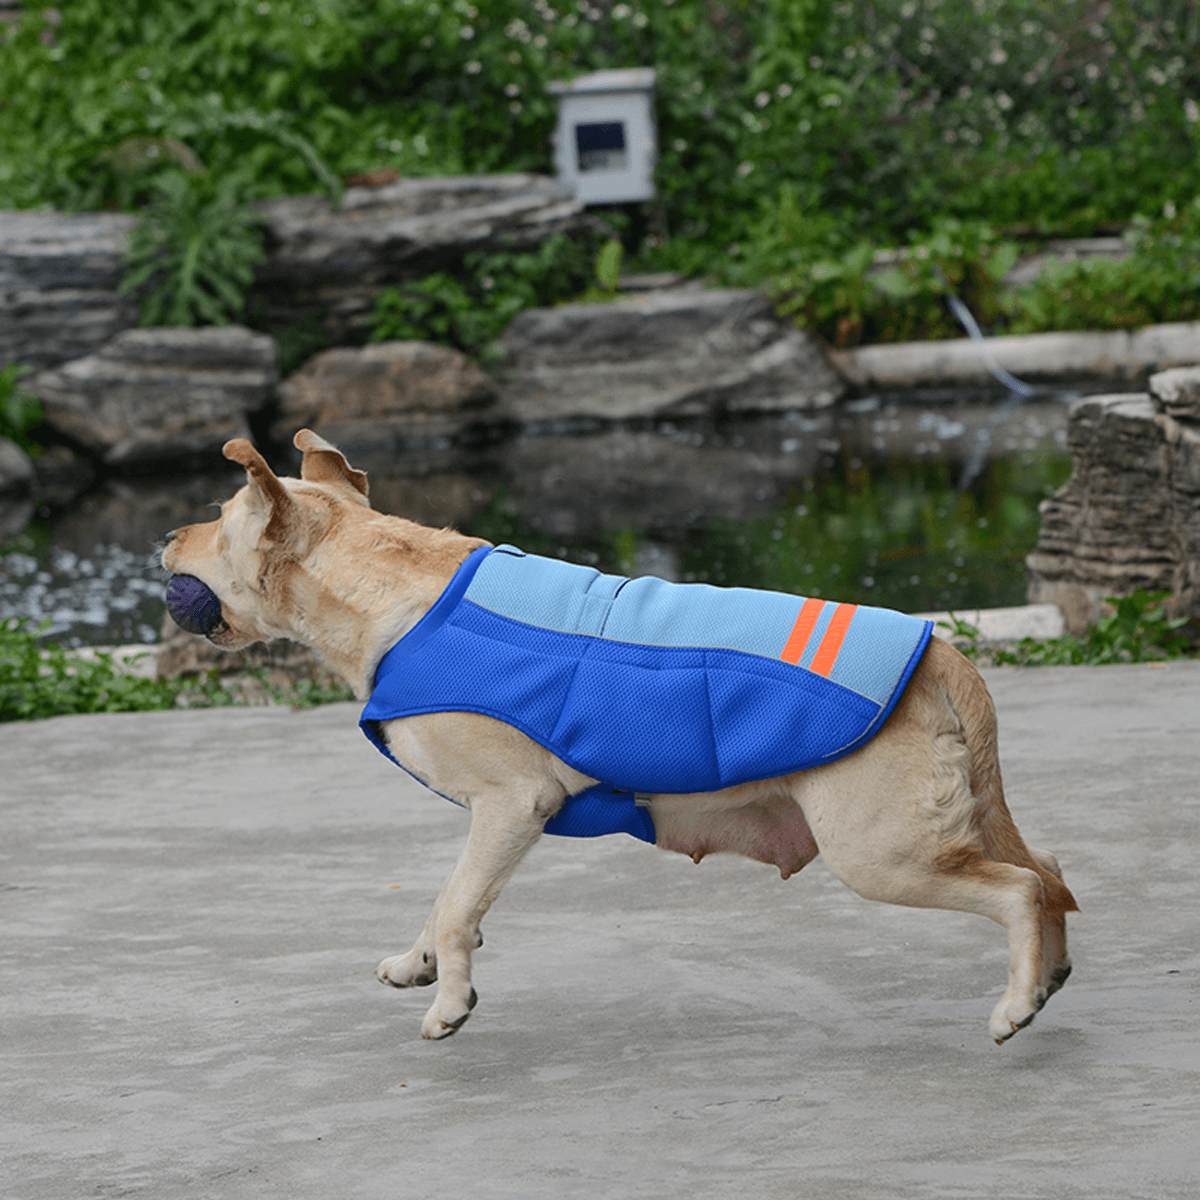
[30,325,277,469]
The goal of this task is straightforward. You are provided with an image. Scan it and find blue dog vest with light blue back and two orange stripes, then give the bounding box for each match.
[360,546,932,841]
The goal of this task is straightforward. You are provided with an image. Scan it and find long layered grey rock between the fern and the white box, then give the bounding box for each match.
[250,175,592,346]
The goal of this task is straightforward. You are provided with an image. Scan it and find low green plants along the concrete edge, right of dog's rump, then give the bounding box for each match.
[948,588,1194,666]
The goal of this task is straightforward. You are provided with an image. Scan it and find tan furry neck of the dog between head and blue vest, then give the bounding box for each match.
[280,506,487,700]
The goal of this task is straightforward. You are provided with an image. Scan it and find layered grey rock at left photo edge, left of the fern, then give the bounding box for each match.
[0,212,138,367]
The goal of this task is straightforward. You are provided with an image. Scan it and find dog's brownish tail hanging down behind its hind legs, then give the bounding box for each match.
[925,638,1079,920]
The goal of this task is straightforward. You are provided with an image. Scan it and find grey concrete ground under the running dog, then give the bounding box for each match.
[0,662,1200,1200]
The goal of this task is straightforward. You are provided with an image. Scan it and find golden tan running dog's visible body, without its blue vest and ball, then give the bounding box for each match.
[162,430,1075,1042]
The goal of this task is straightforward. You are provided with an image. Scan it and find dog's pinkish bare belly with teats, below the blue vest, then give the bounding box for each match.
[650,782,818,880]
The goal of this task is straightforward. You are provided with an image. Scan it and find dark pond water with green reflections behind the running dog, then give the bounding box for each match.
[0,395,1072,646]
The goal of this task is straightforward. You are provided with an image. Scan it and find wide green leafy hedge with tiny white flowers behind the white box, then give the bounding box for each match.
[0,0,1200,253]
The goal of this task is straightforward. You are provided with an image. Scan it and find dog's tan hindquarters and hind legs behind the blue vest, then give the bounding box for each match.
[794,642,1074,1042]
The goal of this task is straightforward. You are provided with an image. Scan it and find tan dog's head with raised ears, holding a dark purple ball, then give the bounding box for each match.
[162,430,373,650]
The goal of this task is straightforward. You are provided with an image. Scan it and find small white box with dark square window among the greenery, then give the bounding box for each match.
[547,67,659,204]
